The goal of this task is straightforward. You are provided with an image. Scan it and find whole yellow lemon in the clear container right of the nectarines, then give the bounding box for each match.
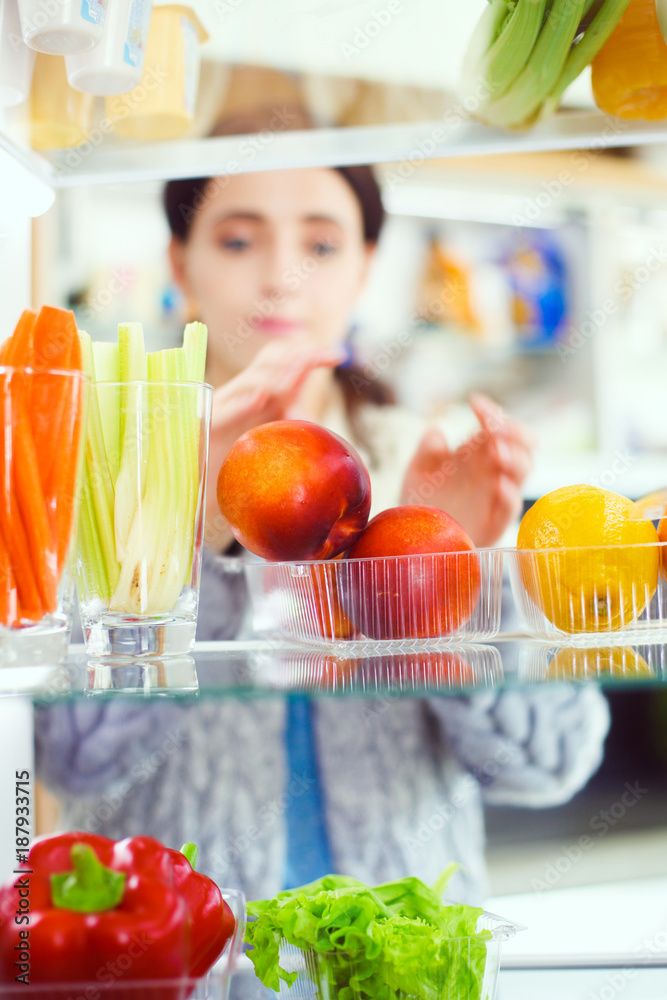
[517,485,660,632]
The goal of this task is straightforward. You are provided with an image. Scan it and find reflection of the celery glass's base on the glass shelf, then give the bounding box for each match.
[86,656,199,697]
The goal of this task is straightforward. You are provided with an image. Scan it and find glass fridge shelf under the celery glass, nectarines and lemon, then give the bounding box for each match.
[15,636,667,703]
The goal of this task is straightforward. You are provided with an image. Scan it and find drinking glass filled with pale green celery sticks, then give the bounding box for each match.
[77,323,211,655]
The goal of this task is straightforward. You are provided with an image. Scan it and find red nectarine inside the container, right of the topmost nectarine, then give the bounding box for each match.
[343,504,481,639]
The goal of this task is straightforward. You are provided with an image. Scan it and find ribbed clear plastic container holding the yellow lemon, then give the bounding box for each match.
[505,543,667,646]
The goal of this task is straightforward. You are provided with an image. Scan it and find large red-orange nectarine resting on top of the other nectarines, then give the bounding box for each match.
[217,420,371,561]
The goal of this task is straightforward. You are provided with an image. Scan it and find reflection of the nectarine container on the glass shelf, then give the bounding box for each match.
[252,645,504,695]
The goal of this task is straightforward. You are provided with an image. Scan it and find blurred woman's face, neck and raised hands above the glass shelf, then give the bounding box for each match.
[165,160,533,551]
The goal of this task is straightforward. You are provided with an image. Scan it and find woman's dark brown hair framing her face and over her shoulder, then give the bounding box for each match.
[163,127,395,462]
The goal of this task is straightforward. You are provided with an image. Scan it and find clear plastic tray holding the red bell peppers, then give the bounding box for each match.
[0,889,246,1000]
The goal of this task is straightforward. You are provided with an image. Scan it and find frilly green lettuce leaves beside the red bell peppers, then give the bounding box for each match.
[246,870,491,1000]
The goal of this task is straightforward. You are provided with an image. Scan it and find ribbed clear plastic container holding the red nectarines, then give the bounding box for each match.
[245,549,503,650]
